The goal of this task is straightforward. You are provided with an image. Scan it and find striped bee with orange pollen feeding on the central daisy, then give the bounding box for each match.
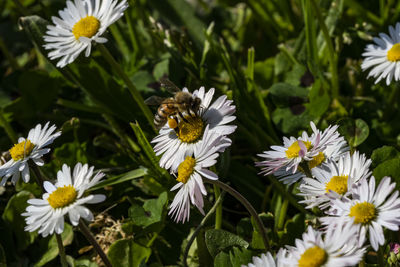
[145,77,201,131]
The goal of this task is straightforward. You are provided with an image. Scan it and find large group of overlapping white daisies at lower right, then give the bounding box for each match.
[249,122,400,266]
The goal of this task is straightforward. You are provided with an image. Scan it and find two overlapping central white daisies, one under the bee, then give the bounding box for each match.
[152,87,236,223]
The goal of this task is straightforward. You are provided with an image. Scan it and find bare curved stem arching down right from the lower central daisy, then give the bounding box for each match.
[204,179,270,251]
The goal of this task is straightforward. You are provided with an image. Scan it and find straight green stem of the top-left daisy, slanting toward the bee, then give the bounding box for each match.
[98,44,156,131]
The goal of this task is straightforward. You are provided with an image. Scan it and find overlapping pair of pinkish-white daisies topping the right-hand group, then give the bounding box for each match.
[256,121,348,184]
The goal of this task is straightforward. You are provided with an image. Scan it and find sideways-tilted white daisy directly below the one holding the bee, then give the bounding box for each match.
[168,127,227,223]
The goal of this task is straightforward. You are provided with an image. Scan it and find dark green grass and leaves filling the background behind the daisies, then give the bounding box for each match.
[0,0,400,266]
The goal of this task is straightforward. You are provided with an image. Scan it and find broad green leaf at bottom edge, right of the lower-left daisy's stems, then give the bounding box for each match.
[107,239,151,267]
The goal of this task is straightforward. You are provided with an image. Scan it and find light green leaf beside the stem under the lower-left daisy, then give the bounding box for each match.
[34,223,74,267]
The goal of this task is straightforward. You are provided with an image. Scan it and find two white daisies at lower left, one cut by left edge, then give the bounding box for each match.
[0,123,105,237]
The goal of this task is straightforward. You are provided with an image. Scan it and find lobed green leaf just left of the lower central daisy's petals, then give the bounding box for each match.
[128,192,168,227]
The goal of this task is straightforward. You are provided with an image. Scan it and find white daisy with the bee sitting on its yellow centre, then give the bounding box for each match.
[151,87,236,173]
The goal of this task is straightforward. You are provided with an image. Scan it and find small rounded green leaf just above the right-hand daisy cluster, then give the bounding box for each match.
[338,118,369,147]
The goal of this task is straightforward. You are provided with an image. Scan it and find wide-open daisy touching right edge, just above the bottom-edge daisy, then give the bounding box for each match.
[320,176,400,251]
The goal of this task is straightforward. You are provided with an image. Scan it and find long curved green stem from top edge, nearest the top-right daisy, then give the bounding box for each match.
[310,0,339,98]
